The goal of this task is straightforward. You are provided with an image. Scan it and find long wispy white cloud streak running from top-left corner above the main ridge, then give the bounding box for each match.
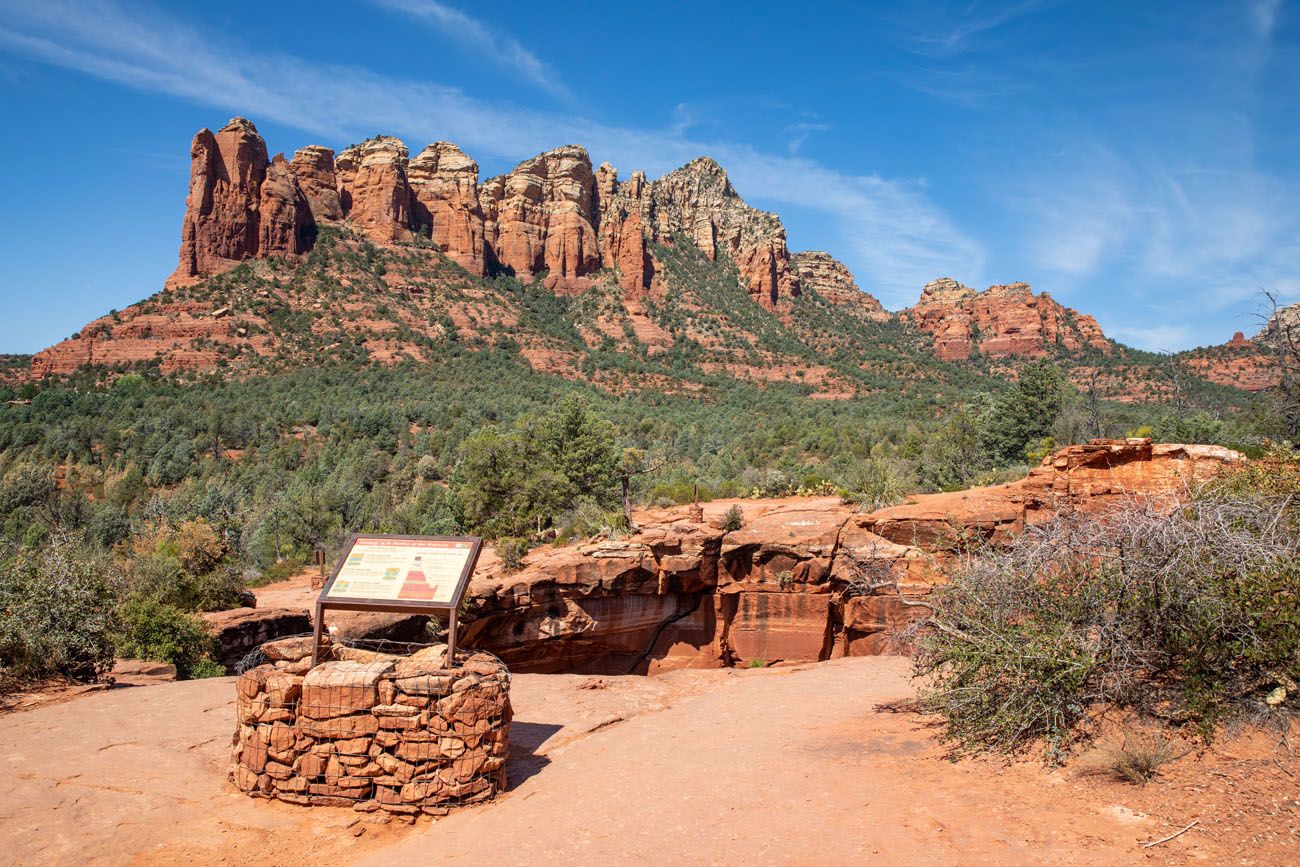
[0,0,984,305]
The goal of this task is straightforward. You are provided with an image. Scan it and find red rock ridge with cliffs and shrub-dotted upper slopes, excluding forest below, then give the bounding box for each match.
[31,118,1263,406]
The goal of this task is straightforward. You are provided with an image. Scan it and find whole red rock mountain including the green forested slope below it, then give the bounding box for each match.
[0,121,1278,684]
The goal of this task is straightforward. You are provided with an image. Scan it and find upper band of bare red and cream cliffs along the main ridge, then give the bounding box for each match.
[172,118,806,309]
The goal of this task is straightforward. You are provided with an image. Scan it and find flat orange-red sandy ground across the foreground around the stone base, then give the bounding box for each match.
[0,658,1300,867]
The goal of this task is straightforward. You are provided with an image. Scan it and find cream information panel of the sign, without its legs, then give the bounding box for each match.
[321,536,480,608]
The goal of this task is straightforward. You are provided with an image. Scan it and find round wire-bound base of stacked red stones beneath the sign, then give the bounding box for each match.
[230,645,511,814]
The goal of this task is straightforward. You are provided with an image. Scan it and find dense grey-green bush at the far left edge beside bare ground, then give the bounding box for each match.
[0,533,116,689]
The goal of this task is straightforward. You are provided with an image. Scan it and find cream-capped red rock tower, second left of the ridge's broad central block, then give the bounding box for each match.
[334,135,411,243]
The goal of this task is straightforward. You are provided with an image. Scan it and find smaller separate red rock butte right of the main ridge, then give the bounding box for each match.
[901,277,1112,361]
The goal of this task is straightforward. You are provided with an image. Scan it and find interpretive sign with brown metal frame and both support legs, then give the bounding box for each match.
[312,534,482,666]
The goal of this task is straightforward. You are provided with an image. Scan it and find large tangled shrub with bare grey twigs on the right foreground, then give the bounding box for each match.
[915,467,1300,755]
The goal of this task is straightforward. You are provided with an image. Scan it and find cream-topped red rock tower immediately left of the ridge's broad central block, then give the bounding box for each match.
[407,142,486,276]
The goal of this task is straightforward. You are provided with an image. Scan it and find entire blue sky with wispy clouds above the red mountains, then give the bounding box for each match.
[0,0,1300,352]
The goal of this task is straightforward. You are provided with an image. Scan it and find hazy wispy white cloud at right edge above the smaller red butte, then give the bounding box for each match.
[1009,135,1300,316]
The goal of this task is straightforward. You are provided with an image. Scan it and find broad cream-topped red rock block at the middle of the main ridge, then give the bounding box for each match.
[478,144,601,279]
